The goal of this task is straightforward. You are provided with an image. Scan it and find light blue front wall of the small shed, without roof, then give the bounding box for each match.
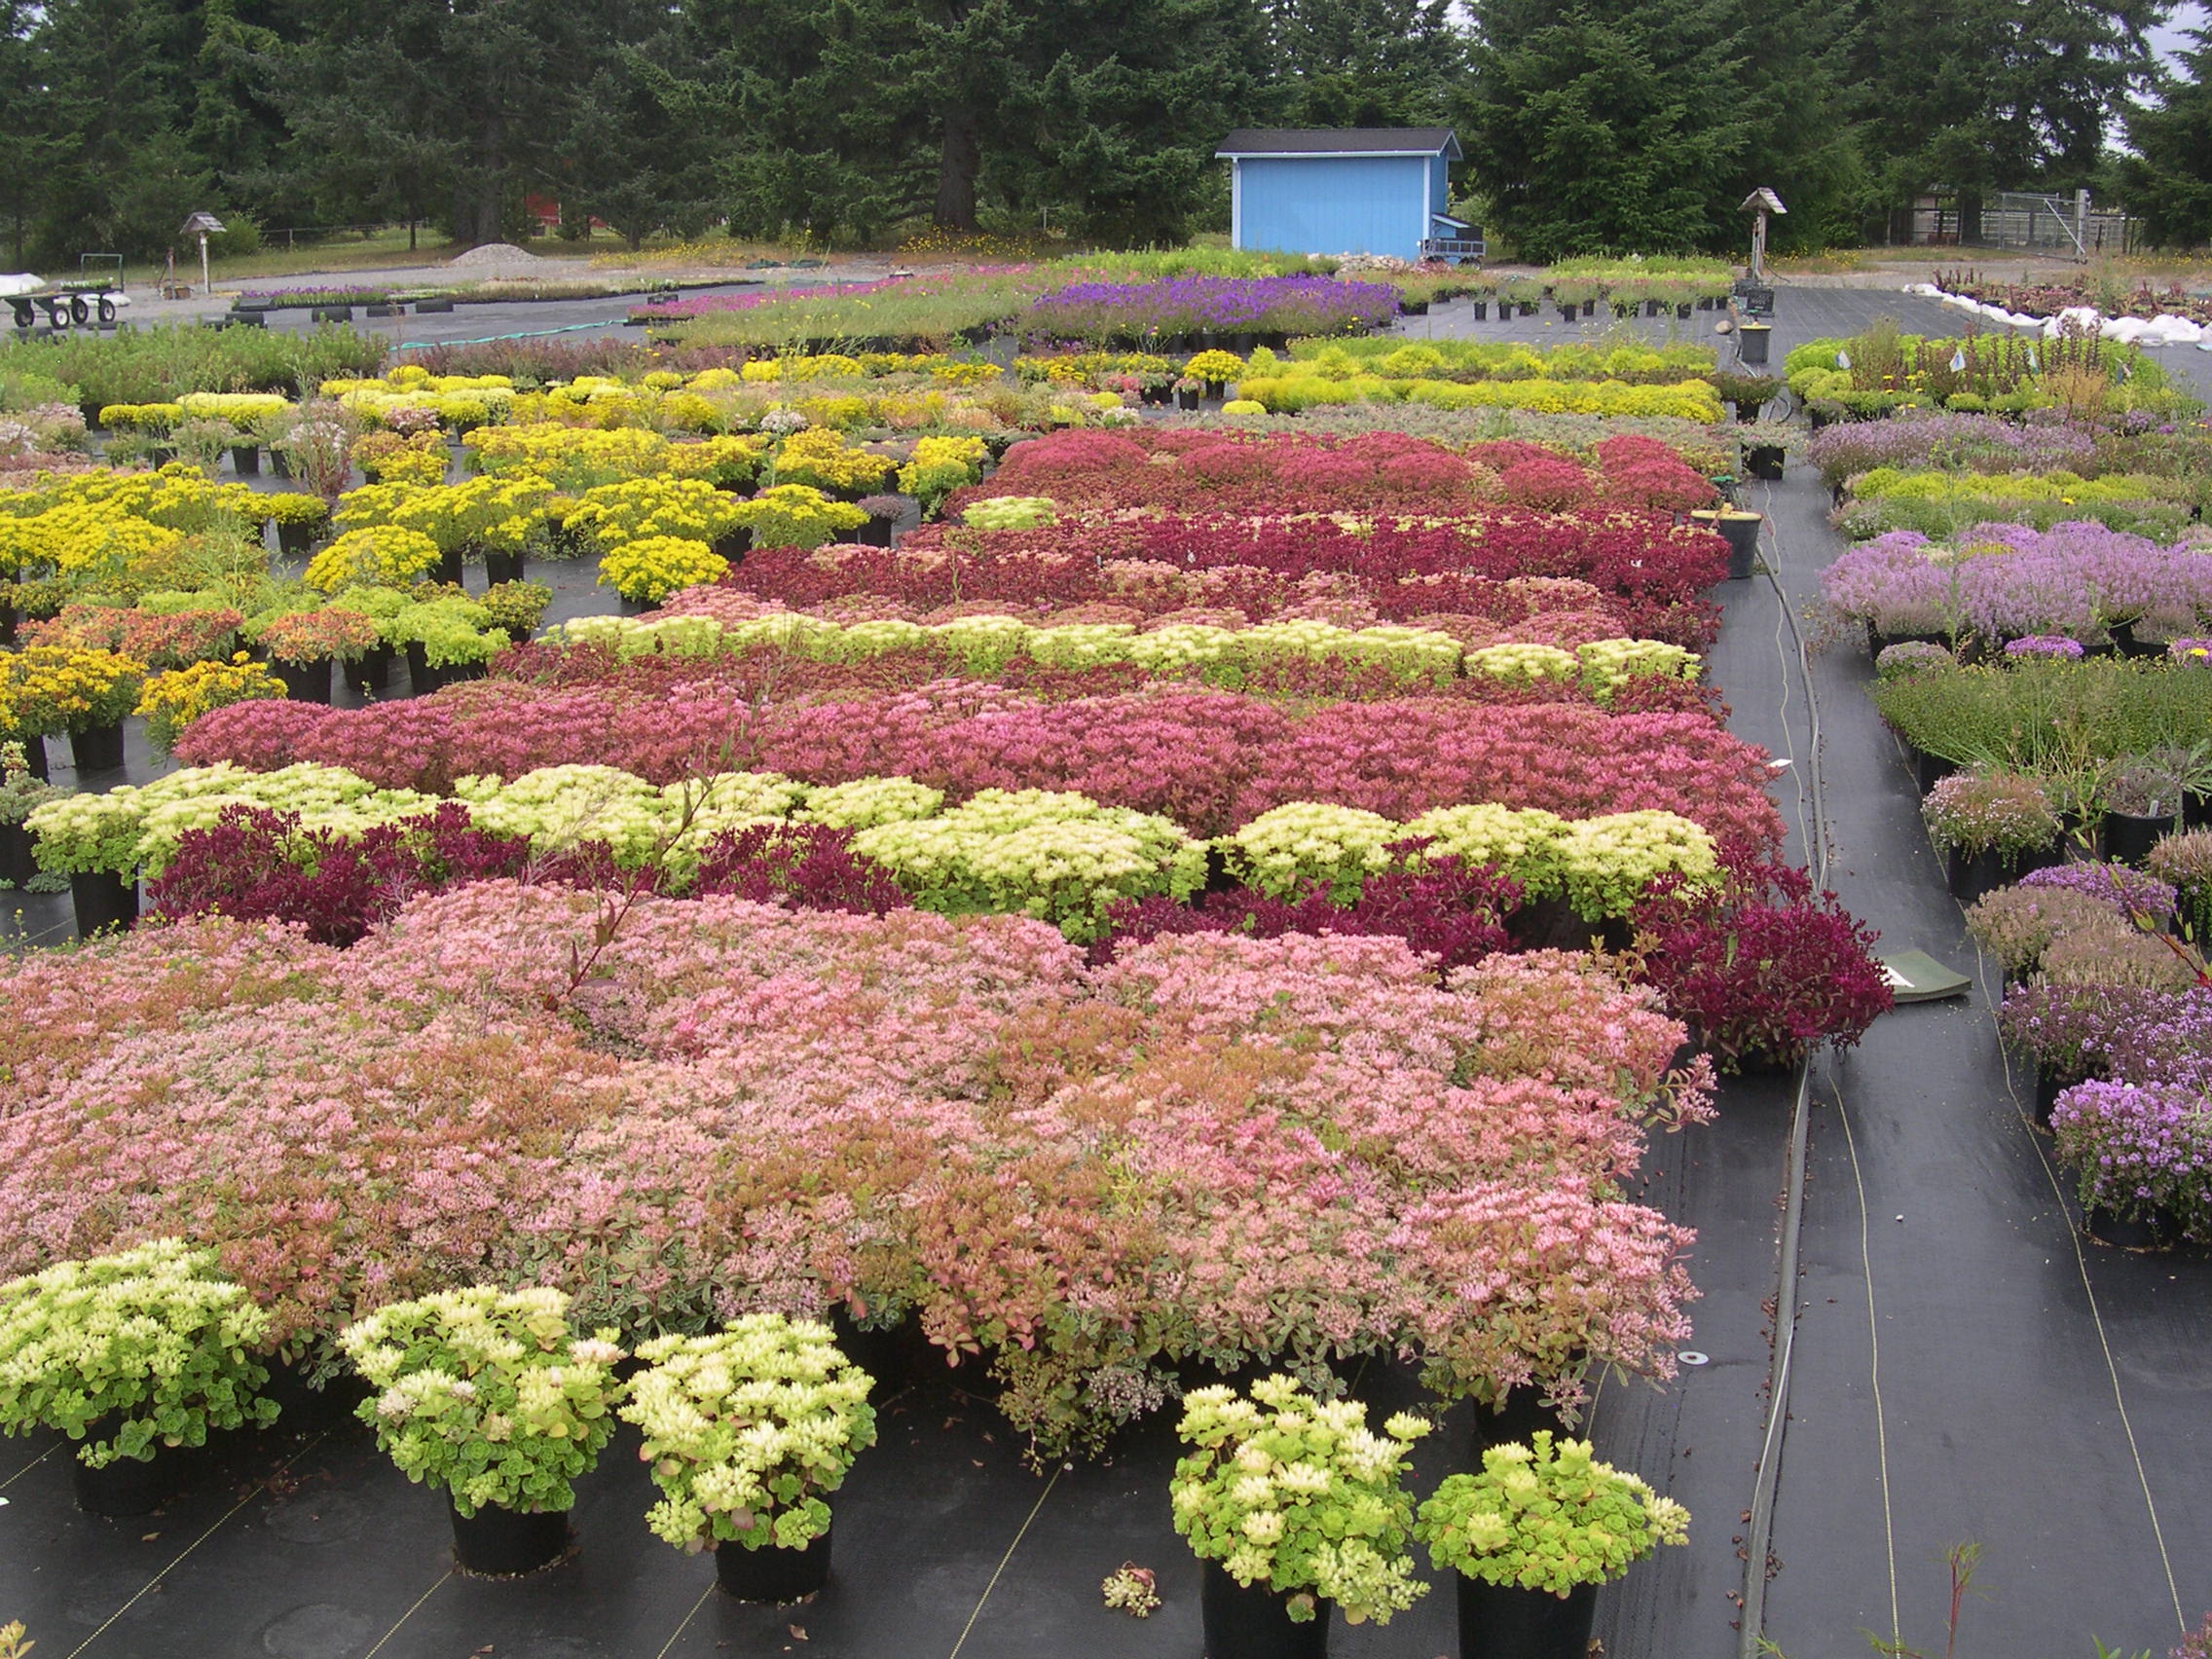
[1235,155,1442,259]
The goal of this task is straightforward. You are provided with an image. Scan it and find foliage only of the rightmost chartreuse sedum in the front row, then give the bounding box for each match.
[1416,1429,1690,1597]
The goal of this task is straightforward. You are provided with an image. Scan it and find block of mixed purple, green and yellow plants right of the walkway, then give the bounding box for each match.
[1789,313,2212,1273]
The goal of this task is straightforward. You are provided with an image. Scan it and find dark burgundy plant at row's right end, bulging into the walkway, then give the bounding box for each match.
[1630,847,1892,1071]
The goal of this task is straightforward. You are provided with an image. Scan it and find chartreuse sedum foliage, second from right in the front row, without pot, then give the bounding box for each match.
[1168,1376,1429,1624]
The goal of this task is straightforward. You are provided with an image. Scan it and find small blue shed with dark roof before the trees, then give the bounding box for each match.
[1214,127,1482,259]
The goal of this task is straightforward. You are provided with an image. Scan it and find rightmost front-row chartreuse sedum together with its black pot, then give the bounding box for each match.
[1416,1429,1690,1659]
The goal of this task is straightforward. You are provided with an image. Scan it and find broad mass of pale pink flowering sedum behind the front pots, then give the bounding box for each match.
[0,898,1706,1449]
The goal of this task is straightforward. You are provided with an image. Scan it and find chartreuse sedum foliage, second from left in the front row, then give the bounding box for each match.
[339,1285,624,1518]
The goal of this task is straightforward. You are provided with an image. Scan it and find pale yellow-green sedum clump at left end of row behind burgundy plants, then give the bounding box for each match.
[24,761,438,880]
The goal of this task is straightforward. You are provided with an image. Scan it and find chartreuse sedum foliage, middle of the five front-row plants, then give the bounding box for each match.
[621,1314,876,1551]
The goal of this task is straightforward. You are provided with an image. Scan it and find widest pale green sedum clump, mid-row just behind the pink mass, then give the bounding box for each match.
[852,790,1205,940]
